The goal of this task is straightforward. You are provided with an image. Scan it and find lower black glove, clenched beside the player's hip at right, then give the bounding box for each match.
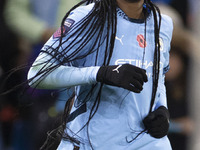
[143,106,169,138]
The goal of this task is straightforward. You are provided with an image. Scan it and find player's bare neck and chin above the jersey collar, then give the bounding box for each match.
[117,0,144,19]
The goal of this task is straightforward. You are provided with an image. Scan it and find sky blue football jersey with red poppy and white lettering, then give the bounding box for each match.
[43,4,173,150]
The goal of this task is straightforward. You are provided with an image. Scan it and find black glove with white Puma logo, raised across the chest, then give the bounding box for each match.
[97,64,148,93]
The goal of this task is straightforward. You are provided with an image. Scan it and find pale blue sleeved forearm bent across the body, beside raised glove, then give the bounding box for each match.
[28,53,99,89]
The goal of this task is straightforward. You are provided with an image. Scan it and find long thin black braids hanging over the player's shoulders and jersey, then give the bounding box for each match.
[33,0,161,149]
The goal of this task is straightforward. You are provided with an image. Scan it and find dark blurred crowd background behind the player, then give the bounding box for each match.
[0,0,200,150]
